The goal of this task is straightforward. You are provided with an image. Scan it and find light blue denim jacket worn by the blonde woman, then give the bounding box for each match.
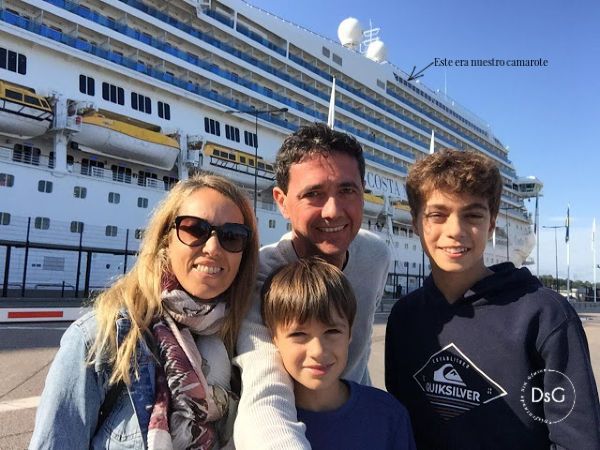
[29,312,154,450]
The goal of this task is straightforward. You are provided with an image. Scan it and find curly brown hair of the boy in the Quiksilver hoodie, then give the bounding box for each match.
[406,149,502,217]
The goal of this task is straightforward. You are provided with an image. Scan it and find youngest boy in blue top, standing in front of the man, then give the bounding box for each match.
[261,257,415,450]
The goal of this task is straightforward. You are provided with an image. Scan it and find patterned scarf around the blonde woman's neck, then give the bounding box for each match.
[148,276,238,450]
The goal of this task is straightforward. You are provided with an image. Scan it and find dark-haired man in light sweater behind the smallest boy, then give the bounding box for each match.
[234,123,390,450]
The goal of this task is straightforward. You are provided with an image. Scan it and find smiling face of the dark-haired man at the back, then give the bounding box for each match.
[273,152,364,267]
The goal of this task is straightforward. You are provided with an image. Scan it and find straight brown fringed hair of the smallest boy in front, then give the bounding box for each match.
[261,256,356,335]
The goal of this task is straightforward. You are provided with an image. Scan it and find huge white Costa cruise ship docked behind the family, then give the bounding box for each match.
[0,0,542,320]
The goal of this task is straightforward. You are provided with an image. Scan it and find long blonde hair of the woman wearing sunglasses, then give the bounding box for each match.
[88,174,258,384]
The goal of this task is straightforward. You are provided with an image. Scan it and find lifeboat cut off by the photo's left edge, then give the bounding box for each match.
[0,80,53,139]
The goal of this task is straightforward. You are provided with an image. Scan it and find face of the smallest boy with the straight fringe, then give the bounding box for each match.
[273,311,350,406]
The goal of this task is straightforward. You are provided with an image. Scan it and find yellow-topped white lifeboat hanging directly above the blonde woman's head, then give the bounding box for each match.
[73,113,179,170]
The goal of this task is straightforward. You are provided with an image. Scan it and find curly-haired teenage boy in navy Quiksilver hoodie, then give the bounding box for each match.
[385,150,600,450]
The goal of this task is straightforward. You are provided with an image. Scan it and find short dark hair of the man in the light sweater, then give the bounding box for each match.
[275,122,365,194]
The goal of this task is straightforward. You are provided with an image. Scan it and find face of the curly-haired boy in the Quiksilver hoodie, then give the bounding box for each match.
[413,190,495,284]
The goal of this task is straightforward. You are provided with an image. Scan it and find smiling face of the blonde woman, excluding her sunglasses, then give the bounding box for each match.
[168,188,244,300]
